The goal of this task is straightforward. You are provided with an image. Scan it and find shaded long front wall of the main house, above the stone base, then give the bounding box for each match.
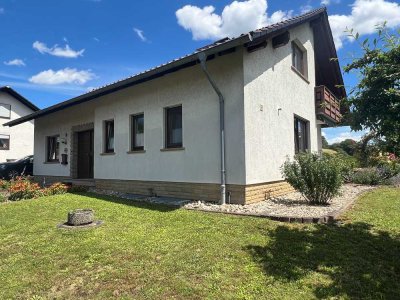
[34,50,245,184]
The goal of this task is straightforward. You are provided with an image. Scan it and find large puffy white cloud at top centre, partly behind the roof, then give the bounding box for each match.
[175,0,292,40]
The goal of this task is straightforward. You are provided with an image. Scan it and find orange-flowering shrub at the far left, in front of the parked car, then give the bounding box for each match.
[8,176,41,201]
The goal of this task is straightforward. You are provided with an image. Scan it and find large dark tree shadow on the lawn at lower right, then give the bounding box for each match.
[246,223,400,299]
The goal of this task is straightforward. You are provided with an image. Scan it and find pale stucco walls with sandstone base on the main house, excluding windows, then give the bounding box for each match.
[34,18,338,203]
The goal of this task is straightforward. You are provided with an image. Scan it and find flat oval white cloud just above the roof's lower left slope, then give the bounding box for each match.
[29,68,95,85]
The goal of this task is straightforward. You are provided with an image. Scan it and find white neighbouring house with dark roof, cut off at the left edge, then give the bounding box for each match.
[0,86,39,162]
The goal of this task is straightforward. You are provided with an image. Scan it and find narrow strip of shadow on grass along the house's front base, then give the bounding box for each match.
[71,192,179,212]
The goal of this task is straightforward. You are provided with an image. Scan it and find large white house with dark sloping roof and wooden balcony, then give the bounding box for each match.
[4,8,346,203]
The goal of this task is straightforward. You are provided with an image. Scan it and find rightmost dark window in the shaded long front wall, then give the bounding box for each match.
[165,106,183,148]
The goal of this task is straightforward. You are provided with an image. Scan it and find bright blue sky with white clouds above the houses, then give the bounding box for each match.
[0,0,400,142]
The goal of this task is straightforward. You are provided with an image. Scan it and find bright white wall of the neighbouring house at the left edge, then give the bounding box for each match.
[0,92,34,162]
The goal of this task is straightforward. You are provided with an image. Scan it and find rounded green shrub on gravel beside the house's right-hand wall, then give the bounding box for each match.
[282,153,343,205]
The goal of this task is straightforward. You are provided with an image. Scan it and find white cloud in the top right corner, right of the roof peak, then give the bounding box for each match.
[329,0,400,49]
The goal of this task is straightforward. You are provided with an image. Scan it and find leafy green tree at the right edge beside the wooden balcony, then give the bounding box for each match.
[344,24,400,155]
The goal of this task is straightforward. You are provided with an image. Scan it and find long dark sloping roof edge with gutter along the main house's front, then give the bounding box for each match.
[3,7,329,127]
